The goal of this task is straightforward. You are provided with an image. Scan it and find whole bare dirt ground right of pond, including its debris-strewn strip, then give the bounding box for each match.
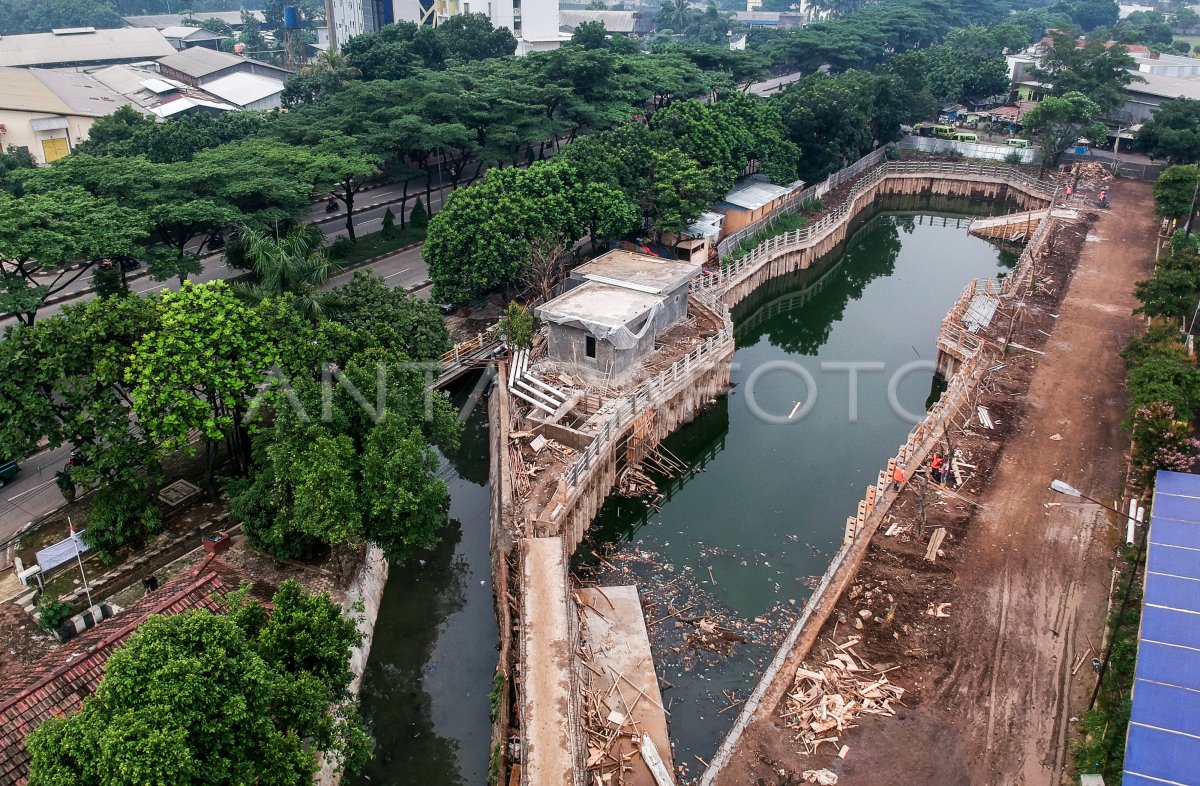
[720,181,1157,786]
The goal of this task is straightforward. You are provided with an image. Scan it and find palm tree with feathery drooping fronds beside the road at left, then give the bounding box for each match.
[238,226,341,319]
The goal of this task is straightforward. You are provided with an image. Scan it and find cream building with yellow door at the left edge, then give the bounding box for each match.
[0,68,141,164]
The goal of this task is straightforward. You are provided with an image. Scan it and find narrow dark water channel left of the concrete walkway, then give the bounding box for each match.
[352,389,499,786]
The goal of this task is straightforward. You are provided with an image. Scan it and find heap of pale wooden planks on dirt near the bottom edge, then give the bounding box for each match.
[784,636,904,756]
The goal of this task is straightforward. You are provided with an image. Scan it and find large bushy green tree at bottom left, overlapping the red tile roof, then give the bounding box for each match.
[26,581,368,786]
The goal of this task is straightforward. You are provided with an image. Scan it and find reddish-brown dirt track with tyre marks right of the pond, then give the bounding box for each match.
[720,181,1157,786]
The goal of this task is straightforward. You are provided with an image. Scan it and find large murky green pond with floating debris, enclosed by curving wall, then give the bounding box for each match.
[578,202,1015,775]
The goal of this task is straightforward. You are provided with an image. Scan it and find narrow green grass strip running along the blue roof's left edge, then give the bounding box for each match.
[1075,547,1144,784]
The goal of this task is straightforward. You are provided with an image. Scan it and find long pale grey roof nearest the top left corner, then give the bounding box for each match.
[0,28,175,66]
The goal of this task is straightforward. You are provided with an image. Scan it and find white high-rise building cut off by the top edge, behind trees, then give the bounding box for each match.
[325,0,564,54]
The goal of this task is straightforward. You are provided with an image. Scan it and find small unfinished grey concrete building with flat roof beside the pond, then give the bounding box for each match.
[535,251,700,379]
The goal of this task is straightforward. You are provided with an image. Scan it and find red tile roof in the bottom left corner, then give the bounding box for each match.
[0,556,256,786]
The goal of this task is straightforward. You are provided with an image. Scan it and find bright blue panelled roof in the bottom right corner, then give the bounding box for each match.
[1121,472,1200,786]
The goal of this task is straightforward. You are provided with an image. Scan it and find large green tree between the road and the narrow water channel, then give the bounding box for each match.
[228,349,458,559]
